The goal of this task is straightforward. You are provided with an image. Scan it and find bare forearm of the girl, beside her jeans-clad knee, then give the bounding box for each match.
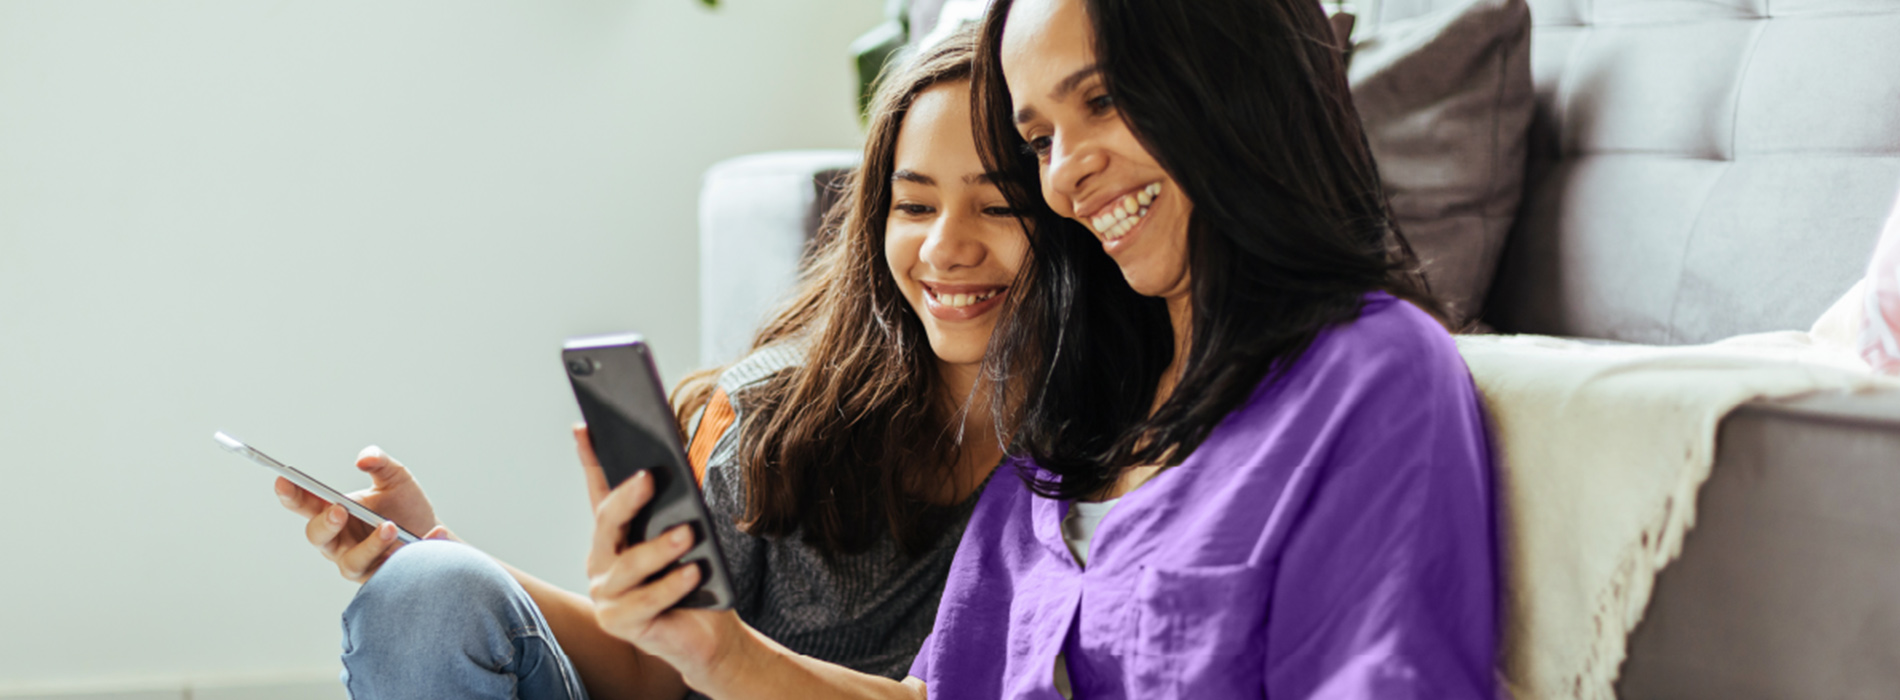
[498,559,686,700]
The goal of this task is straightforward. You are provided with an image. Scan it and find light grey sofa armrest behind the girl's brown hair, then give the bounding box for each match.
[699,150,859,367]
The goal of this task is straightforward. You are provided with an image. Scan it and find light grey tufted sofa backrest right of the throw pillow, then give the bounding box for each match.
[1368,0,1900,344]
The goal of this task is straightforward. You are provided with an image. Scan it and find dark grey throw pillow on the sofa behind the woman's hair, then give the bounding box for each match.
[1347,0,1533,325]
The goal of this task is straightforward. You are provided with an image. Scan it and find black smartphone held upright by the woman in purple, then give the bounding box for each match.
[561,333,732,611]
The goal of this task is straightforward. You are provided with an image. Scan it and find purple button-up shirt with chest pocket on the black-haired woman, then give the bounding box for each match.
[910,293,1499,700]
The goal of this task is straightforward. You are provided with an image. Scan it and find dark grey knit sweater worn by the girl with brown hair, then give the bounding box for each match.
[690,346,982,698]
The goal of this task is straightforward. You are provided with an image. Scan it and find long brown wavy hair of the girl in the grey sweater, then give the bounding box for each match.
[673,30,1003,555]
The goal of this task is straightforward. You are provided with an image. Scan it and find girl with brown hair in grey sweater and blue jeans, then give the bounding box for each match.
[277,32,1028,700]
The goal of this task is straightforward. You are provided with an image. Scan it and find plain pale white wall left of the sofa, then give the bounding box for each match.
[0,0,882,692]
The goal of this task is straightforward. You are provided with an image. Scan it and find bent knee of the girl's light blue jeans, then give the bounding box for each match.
[342,540,587,700]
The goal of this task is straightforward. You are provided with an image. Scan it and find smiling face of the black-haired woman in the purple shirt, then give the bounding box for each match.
[1001,0,1193,301]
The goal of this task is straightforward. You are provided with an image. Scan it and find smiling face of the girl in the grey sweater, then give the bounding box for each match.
[884,82,1030,369]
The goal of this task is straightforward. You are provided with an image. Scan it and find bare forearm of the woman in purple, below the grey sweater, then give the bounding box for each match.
[694,626,925,700]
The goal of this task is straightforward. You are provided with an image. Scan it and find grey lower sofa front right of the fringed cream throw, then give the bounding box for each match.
[1619,392,1900,700]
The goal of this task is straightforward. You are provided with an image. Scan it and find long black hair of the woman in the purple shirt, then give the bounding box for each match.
[971,0,1444,498]
